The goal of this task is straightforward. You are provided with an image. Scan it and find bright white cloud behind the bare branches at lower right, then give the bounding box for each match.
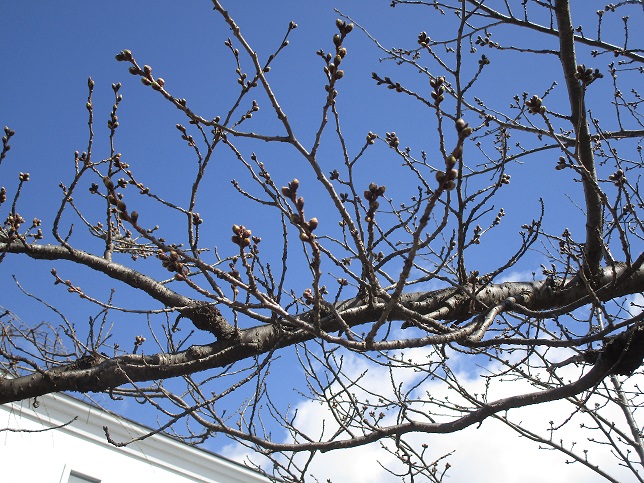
[224,349,632,483]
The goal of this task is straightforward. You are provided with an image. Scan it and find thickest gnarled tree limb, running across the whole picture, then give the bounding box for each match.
[0,260,644,404]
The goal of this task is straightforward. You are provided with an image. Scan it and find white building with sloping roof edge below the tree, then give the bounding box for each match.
[0,394,268,483]
